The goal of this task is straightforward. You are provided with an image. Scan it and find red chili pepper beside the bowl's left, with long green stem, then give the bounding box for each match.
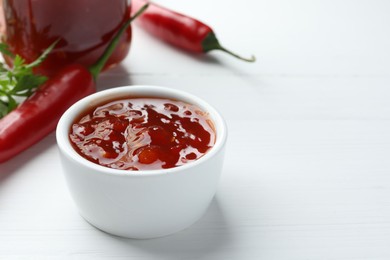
[0,5,147,162]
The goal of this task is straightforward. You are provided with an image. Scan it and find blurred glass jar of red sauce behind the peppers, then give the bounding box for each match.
[0,0,131,75]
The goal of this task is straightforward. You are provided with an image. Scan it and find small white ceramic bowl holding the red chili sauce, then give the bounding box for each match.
[56,86,227,239]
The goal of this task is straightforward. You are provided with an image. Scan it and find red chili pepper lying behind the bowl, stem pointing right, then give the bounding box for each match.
[132,0,256,62]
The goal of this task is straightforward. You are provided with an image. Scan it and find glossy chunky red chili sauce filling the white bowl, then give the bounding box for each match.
[69,97,216,170]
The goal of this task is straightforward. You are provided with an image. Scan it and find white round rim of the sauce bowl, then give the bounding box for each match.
[56,85,227,178]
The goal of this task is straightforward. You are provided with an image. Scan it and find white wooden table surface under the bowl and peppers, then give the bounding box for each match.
[0,0,390,260]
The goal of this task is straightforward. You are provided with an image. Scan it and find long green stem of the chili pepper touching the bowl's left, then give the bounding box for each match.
[89,3,149,80]
